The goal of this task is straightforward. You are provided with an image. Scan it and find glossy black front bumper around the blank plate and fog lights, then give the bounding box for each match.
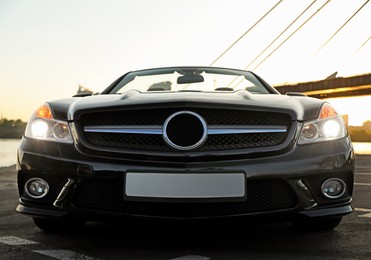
[17,138,354,220]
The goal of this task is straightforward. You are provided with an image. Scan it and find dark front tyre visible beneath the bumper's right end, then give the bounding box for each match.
[292,217,343,230]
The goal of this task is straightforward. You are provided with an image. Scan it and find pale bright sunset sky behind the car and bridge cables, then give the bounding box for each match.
[0,0,371,124]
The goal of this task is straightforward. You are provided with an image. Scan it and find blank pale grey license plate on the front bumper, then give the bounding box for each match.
[125,172,246,200]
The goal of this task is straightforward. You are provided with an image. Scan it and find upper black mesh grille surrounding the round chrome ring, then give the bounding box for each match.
[79,107,291,152]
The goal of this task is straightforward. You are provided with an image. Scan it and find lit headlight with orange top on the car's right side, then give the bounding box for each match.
[298,103,347,144]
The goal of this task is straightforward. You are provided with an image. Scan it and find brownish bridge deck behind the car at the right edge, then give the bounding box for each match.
[274,73,371,99]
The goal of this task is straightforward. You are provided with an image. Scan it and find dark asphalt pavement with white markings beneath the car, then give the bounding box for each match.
[0,156,371,260]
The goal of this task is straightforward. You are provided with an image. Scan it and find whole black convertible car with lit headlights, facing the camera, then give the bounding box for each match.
[17,67,354,230]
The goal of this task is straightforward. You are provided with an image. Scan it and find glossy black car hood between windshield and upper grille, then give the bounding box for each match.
[49,91,324,121]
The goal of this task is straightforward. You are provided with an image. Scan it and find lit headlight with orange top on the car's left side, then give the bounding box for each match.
[25,104,72,143]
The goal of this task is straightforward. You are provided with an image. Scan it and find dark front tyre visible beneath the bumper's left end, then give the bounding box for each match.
[33,218,84,232]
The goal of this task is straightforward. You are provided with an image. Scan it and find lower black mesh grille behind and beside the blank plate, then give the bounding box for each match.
[73,179,298,218]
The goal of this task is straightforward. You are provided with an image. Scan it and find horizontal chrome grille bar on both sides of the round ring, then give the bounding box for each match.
[84,125,287,135]
